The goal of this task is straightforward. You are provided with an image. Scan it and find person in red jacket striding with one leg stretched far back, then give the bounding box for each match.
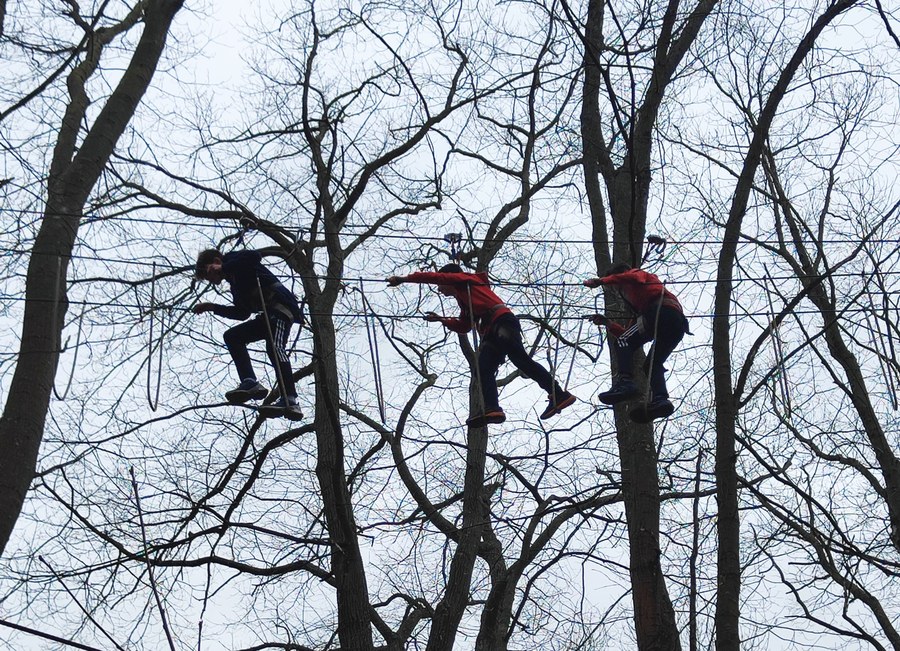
[387,263,576,427]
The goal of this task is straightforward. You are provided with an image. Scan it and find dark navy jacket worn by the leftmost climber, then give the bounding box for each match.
[213,251,303,323]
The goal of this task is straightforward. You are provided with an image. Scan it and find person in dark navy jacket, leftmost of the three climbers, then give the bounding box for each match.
[193,249,303,420]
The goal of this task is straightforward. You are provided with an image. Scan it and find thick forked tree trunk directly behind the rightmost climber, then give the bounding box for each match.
[581,0,684,651]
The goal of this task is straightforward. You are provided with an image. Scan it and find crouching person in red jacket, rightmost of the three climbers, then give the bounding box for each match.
[584,263,690,422]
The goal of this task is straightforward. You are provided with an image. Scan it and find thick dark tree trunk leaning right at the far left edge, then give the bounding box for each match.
[0,0,183,555]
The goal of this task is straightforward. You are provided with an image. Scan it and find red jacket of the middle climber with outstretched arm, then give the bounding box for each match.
[403,271,512,335]
